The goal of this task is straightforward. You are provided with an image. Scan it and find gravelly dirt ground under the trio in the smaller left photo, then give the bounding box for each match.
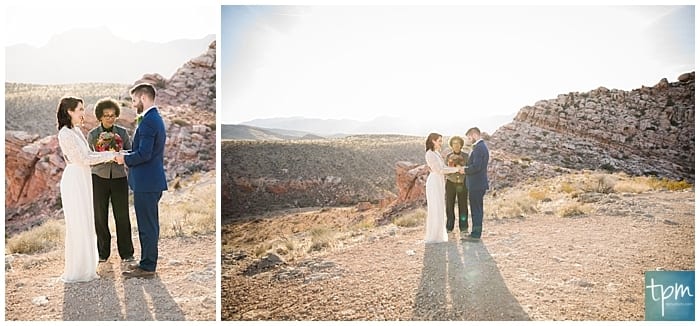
[5,234,217,320]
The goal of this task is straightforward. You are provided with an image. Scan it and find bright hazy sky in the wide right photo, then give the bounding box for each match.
[223,5,695,123]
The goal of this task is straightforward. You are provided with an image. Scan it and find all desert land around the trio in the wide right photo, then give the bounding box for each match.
[221,72,695,320]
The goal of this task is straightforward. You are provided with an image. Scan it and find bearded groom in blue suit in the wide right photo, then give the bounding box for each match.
[464,127,489,241]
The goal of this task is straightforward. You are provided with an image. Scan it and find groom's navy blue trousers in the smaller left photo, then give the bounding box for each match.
[134,191,163,272]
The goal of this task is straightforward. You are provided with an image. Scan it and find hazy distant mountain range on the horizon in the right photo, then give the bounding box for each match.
[221,113,515,140]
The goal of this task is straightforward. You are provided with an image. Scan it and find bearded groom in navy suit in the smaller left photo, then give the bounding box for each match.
[122,83,168,277]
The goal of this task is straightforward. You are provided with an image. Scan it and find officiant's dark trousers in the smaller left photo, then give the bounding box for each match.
[92,174,134,259]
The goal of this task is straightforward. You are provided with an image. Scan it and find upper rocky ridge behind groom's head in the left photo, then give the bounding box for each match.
[134,41,216,112]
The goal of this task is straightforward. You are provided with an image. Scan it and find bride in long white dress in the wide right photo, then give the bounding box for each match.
[425,133,460,243]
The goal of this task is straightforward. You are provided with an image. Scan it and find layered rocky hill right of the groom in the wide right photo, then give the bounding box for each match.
[490,72,695,182]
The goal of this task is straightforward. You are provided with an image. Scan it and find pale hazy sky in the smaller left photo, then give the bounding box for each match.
[3,0,220,46]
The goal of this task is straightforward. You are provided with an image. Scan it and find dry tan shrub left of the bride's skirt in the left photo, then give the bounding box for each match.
[5,219,65,254]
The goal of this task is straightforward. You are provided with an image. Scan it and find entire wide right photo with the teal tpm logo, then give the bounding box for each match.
[217,5,695,321]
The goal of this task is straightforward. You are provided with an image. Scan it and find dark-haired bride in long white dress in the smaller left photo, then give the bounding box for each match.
[56,97,116,283]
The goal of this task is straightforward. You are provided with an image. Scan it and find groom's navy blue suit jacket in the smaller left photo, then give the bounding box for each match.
[124,108,168,192]
